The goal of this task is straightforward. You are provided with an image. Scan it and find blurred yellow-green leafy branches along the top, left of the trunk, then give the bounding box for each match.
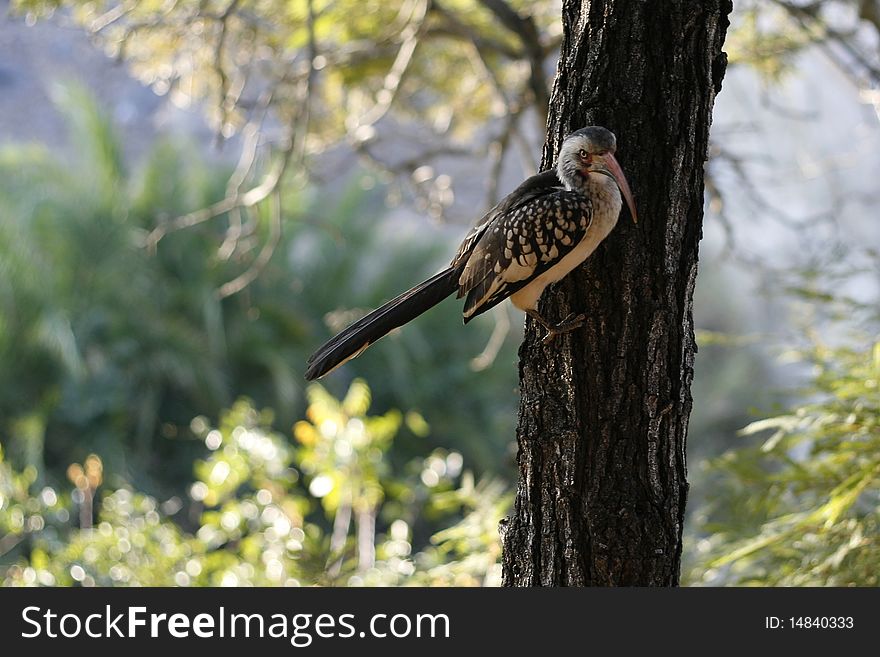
[14,0,559,145]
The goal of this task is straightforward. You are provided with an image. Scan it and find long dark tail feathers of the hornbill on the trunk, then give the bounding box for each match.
[306,267,460,381]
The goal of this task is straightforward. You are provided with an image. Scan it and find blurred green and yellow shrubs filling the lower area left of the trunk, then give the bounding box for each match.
[0,90,515,585]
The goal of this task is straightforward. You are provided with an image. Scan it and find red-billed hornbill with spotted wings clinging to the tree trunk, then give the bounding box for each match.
[305,126,638,381]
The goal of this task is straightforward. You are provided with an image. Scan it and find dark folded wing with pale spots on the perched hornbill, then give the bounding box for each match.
[458,189,593,322]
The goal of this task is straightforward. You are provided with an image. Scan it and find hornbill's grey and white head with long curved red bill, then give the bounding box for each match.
[556,126,638,222]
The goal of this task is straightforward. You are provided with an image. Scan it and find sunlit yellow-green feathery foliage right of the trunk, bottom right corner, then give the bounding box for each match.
[689,294,880,586]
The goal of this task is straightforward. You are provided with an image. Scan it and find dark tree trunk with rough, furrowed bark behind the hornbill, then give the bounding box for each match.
[502,0,731,586]
